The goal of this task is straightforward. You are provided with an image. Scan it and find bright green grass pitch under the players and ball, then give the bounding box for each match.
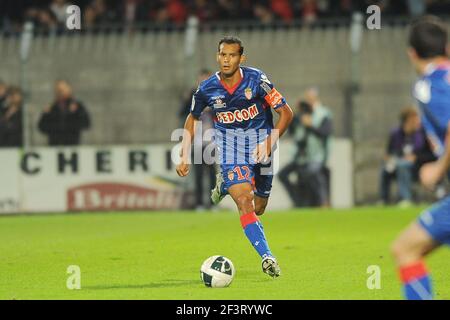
[0,208,450,299]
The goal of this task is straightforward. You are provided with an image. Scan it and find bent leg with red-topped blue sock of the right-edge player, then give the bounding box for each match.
[391,222,440,300]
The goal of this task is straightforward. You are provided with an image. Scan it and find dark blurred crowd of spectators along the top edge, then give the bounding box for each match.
[0,0,450,33]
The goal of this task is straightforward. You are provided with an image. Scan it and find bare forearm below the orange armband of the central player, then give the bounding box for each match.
[253,104,294,163]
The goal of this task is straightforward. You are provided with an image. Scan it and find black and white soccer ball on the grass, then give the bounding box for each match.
[200,256,235,288]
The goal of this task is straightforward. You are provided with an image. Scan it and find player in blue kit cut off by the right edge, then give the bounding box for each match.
[392,16,450,300]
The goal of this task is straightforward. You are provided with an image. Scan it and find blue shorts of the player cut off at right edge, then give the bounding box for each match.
[418,196,450,246]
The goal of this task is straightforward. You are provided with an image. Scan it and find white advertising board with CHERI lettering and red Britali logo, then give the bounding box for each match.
[0,146,187,213]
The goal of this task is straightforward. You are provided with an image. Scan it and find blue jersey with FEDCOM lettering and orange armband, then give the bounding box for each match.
[191,66,286,163]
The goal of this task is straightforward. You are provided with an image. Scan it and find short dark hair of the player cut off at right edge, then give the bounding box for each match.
[409,16,448,59]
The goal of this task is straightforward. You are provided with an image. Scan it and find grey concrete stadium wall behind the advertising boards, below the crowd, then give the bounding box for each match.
[0,26,446,203]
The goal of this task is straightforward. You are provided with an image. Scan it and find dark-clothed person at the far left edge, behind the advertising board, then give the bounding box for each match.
[0,87,23,147]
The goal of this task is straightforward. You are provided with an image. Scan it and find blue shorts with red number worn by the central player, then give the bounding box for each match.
[220,163,273,198]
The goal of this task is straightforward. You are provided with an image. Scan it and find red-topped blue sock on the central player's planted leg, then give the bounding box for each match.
[241,212,273,258]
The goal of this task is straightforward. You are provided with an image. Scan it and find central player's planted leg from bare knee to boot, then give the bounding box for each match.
[228,183,281,278]
